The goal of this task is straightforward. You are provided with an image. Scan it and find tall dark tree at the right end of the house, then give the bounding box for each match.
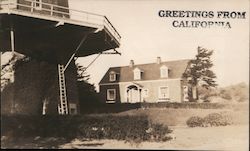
[183,47,217,100]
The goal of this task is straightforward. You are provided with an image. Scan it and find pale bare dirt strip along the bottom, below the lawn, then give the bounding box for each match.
[60,125,249,151]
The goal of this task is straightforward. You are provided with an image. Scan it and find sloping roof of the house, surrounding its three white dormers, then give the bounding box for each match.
[100,59,190,84]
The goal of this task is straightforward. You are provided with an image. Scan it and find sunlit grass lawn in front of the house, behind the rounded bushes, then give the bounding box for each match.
[116,104,249,126]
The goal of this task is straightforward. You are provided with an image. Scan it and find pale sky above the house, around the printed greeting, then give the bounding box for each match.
[69,0,249,89]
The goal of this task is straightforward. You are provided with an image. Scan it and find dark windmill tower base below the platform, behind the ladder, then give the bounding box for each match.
[1,57,79,115]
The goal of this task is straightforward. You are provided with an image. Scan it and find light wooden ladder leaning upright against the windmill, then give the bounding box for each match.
[58,64,68,115]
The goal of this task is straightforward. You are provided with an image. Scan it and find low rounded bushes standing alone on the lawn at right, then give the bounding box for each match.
[186,113,233,127]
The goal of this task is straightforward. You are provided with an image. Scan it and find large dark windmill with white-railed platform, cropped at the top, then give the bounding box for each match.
[0,0,121,115]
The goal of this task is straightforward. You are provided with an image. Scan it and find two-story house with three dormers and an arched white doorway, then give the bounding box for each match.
[99,57,189,103]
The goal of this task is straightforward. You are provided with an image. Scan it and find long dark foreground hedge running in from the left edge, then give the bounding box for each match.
[1,115,171,141]
